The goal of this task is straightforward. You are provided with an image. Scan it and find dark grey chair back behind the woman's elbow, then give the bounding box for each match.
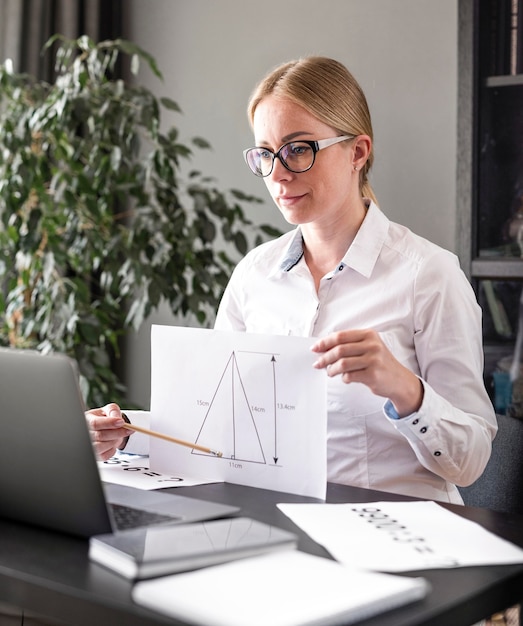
[459,415,523,513]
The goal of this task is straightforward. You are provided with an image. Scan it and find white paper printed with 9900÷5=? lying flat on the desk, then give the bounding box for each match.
[278,501,523,572]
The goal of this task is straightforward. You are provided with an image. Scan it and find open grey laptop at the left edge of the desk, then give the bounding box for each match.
[0,348,239,538]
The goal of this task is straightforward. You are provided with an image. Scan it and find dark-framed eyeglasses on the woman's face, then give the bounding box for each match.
[243,135,356,178]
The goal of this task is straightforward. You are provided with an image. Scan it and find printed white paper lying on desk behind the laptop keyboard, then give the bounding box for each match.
[98,453,216,490]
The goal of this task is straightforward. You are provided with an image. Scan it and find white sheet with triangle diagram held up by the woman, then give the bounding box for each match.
[150,326,327,499]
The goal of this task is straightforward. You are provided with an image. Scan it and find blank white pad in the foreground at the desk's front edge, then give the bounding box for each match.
[132,550,428,626]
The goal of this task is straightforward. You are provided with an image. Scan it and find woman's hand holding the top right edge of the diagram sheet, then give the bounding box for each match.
[312,330,423,417]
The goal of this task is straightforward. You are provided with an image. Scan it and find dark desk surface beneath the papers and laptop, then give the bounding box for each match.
[0,483,523,626]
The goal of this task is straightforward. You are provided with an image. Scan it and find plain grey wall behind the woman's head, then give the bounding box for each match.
[127,0,458,406]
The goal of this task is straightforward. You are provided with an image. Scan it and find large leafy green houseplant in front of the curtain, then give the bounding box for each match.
[0,36,277,406]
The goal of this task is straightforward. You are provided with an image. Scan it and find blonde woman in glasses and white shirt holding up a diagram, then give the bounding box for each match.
[88,57,496,502]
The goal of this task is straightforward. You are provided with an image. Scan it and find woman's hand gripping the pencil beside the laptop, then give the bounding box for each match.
[85,403,132,461]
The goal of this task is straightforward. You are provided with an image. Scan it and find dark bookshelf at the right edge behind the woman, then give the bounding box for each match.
[468,0,523,418]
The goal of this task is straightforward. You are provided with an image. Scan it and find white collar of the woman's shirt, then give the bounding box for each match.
[277,200,389,278]
